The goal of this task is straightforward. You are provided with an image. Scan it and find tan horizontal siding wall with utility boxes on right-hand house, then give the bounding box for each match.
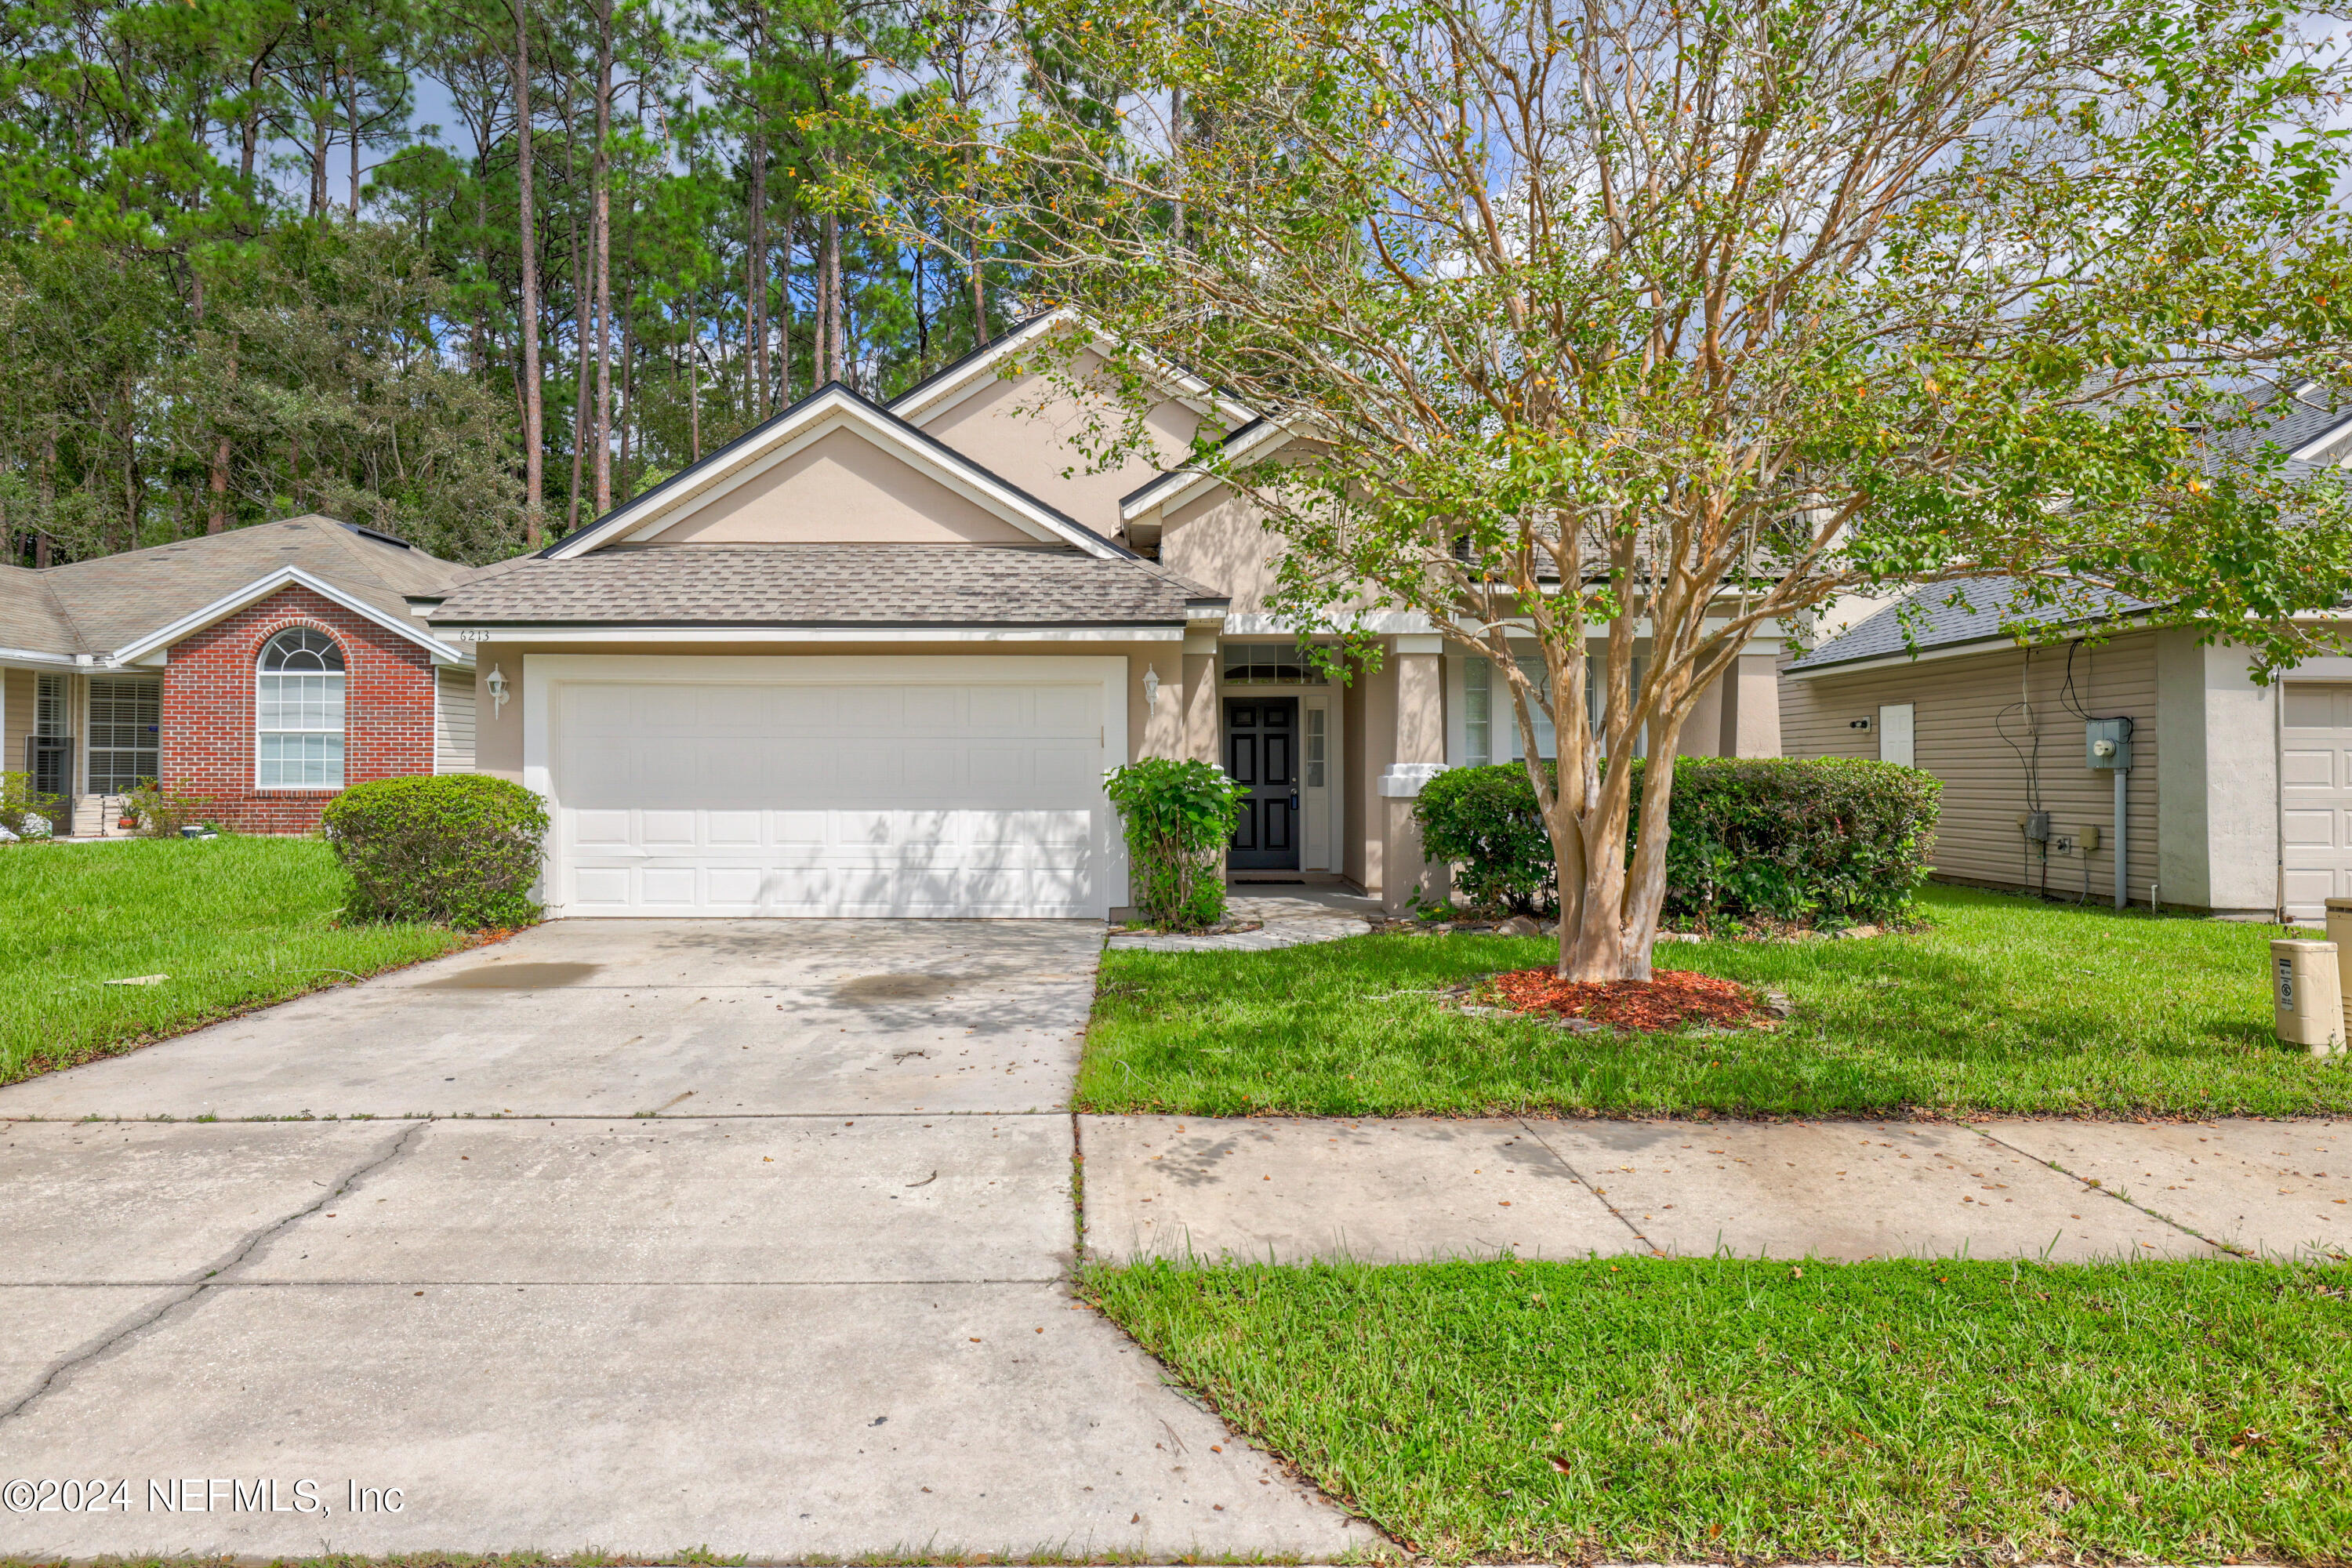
[1780,633,2161,902]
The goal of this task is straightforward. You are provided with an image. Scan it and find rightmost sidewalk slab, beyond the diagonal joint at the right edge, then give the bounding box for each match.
[1983,1116,2352,1258]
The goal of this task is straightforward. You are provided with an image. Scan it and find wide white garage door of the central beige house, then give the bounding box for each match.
[550,666,1112,919]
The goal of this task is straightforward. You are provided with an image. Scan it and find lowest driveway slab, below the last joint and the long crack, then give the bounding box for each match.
[0,1286,1371,1559]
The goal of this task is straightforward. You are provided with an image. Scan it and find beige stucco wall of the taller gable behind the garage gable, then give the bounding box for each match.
[915,355,1200,536]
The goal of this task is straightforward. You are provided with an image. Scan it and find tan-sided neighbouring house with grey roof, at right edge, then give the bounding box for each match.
[1780,579,2352,919]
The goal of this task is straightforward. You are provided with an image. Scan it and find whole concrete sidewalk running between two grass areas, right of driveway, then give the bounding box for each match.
[1080,1116,2352,1262]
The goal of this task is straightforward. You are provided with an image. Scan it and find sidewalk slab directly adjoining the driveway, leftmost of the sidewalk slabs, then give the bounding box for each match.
[1077,1116,1635,1262]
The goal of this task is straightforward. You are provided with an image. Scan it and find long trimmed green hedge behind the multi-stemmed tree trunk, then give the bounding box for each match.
[1414,757,1943,926]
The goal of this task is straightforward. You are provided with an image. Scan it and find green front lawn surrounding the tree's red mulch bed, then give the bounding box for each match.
[1077,888,2352,1116]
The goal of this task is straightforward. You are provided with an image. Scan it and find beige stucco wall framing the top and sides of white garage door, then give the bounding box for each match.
[473,642,1188,781]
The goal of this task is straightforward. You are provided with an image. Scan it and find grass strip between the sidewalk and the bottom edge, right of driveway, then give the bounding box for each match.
[1082,1258,2352,1563]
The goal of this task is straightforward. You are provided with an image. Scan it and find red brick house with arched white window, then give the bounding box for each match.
[0,517,475,834]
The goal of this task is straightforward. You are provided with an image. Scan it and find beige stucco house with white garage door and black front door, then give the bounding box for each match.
[412,315,1778,916]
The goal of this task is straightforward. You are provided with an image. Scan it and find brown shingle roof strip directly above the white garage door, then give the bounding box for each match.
[428,543,1225,626]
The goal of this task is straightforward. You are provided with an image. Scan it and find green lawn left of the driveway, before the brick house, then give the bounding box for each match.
[0,837,463,1083]
